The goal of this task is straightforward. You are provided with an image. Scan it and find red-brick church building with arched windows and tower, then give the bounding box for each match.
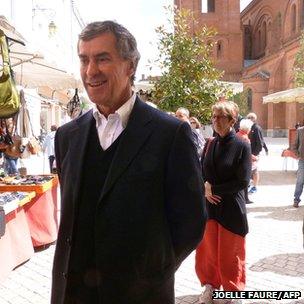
[174,0,304,137]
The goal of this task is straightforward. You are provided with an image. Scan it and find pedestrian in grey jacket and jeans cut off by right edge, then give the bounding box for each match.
[291,127,304,208]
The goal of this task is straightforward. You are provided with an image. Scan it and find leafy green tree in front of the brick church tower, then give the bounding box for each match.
[152,8,231,122]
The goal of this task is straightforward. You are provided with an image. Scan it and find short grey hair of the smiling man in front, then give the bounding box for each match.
[78,20,140,84]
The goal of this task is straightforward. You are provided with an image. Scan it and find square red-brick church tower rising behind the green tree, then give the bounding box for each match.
[174,0,243,81]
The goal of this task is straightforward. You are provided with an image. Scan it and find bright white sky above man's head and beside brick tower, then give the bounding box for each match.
[75,0,252,80]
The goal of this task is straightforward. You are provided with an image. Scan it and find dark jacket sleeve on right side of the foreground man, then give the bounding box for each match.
[165,123,206,268]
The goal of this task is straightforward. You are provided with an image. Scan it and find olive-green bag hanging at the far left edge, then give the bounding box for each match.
[0,29,20,118]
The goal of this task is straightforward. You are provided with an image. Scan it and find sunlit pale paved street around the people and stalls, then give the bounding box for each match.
[0,138,304,304]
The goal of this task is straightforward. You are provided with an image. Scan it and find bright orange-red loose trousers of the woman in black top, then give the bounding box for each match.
[195,220,246,291]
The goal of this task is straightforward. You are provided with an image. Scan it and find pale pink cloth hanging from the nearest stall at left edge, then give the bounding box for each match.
[0,207,34,282]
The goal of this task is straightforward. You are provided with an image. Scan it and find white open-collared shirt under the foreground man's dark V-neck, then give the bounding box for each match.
[93,93,136,150]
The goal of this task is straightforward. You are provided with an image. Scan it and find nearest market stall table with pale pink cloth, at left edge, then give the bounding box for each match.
[0,192,35,282]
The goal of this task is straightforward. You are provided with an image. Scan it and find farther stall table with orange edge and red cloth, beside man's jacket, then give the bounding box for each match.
[0,175,58,247]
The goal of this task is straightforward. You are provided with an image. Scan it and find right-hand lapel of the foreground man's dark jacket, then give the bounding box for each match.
[100,97,153,200]
